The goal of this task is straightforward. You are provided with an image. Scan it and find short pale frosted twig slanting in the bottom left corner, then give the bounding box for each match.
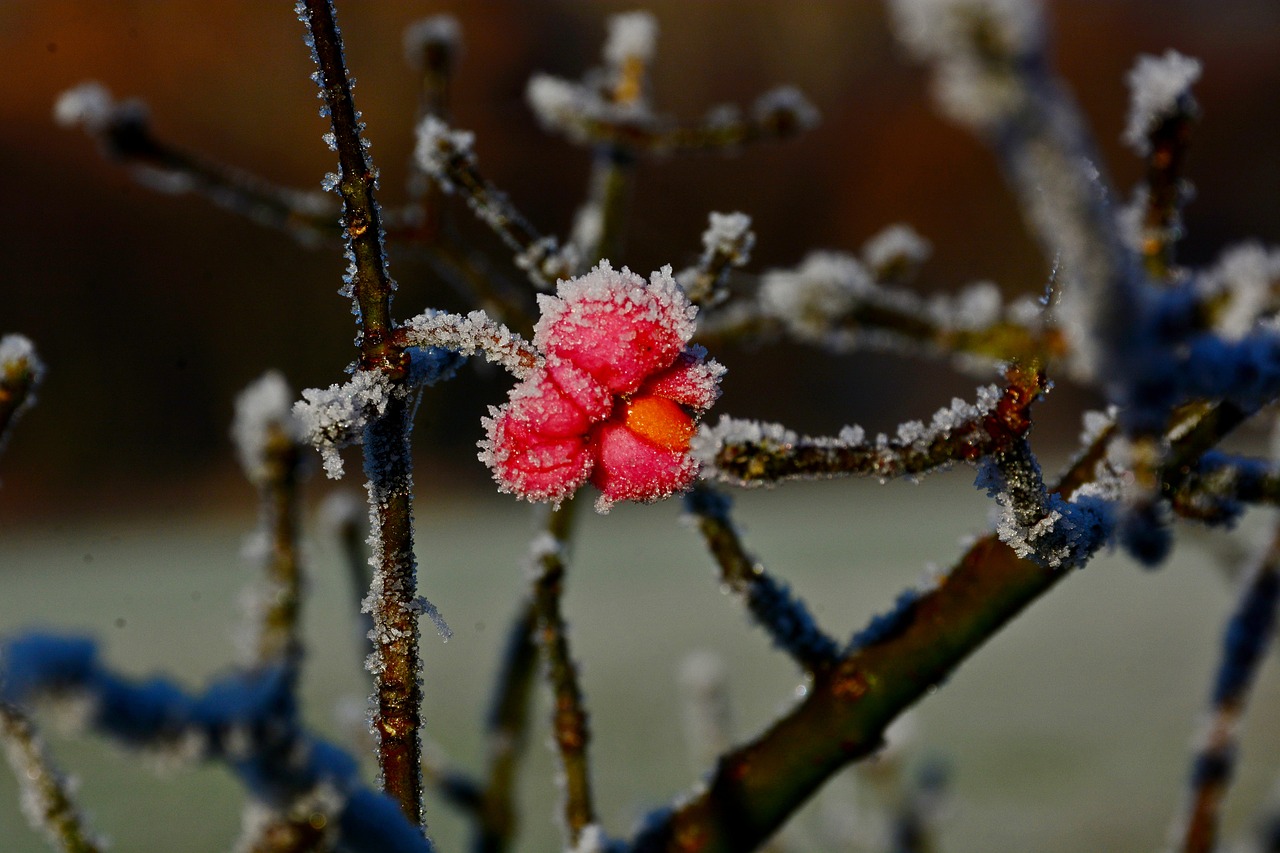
[0,701,105,853]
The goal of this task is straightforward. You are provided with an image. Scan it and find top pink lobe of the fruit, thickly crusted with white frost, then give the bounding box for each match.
[534,261,696,393]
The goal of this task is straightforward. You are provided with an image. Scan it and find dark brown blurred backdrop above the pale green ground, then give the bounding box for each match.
[0,0,1280,517]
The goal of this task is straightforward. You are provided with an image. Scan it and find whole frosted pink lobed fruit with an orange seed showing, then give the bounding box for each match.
[480,261,724,512]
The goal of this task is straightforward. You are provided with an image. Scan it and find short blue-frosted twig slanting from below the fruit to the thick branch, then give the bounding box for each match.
[685,485,840,672]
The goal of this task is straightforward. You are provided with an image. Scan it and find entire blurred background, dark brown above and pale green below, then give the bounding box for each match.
[0,0,1280,852]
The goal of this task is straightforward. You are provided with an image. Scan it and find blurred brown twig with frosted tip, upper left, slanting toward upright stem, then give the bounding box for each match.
[54,82,338,245]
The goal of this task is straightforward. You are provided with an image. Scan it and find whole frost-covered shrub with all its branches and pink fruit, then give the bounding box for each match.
[0,0,1280,853]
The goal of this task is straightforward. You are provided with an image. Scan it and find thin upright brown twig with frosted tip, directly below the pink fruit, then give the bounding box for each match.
[530,498,595,848]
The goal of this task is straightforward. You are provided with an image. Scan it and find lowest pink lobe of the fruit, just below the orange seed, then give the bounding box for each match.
[591,420,698,512]
